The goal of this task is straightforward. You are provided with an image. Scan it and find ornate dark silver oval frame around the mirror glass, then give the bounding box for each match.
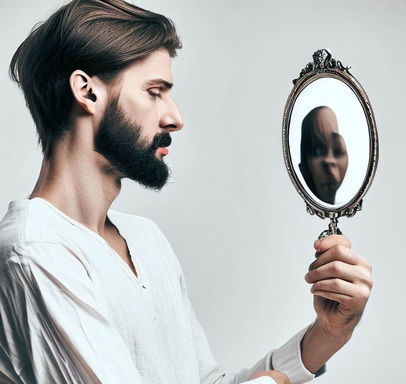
[282,49,378,223]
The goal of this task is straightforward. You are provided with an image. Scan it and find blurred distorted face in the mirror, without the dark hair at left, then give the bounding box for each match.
[307,108,348,204]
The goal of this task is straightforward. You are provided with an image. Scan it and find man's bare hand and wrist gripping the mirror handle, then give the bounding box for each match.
[302,235,372,372]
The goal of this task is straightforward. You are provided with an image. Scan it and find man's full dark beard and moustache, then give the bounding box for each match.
[95,97,172,190]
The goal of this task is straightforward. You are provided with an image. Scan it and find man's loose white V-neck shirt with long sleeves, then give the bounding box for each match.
[0,198,313,384]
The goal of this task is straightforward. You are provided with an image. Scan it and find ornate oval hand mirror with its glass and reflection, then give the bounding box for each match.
[282,49,378,237]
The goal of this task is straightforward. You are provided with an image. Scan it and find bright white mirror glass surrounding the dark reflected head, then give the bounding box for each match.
[289,77,370,208]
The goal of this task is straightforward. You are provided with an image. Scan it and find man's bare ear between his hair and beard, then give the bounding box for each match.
[69,69,97,115]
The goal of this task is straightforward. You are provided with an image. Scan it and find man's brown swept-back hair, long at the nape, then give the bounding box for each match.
[9,0,181,157]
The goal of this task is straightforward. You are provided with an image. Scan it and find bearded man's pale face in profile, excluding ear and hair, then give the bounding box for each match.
[95,50,183,189]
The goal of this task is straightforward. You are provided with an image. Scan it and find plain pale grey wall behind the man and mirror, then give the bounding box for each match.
[0,0,406,384]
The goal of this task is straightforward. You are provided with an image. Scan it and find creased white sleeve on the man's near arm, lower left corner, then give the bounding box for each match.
[0,243,142,384]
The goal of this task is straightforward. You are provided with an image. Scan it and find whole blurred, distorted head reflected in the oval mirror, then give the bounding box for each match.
[299,106,348,204]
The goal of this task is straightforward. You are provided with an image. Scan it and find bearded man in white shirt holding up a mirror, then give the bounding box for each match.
[0,0,372,384]
